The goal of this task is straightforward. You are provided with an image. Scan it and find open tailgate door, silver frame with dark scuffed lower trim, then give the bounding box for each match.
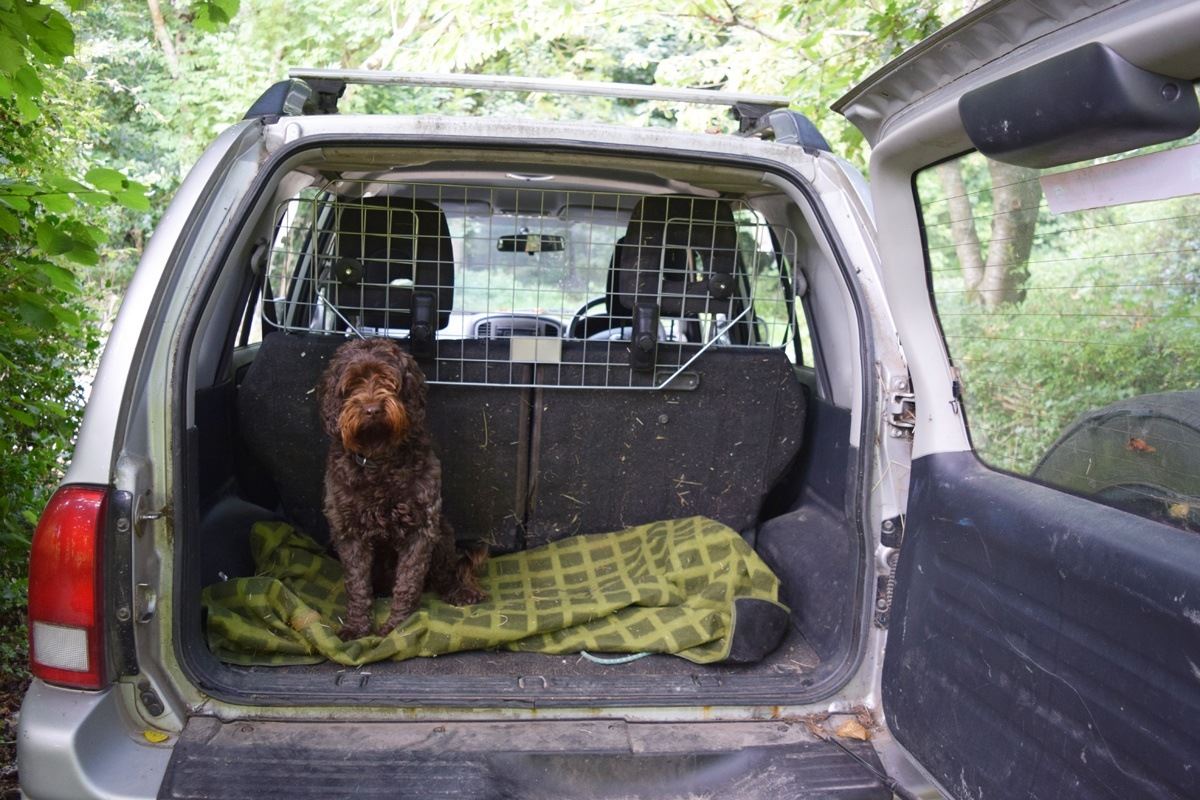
[839,1,1200,798]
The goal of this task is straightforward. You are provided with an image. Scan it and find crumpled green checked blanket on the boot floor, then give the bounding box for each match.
[203,517,787,666]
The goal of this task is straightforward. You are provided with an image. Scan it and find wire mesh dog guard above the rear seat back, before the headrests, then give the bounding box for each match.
[264,176,797,389]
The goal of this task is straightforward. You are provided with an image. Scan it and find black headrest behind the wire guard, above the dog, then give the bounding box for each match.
[329,197,454,330]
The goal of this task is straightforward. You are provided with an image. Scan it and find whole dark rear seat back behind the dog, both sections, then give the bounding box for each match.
[238,333,805,552]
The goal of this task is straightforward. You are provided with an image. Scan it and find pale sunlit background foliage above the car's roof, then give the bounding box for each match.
[80,0,954,200]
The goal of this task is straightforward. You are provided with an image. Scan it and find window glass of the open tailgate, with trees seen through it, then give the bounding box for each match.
[917,138,1200,531]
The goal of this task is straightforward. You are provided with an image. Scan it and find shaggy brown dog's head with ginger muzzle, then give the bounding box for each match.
[317,338,425,458]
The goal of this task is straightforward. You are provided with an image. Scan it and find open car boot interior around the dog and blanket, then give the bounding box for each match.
[180,149,866,705]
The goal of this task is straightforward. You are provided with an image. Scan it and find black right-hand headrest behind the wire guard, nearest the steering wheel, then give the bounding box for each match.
[616,196,738,317]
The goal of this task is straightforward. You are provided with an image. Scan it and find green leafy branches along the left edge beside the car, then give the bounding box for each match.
[0,0,194,676]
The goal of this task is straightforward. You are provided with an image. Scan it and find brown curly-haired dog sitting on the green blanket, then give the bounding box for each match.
[318,338,486,639]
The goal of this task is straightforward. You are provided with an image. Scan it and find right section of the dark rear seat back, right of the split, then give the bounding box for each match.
[526,342,805,547]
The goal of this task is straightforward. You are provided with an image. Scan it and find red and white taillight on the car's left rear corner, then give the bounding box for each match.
[29,486,108,688]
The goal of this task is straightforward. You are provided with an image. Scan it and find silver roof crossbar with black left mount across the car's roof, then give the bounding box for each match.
[246,67,788,118]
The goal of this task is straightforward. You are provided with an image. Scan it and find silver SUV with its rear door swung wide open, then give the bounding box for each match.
[19,0,1200,799]
